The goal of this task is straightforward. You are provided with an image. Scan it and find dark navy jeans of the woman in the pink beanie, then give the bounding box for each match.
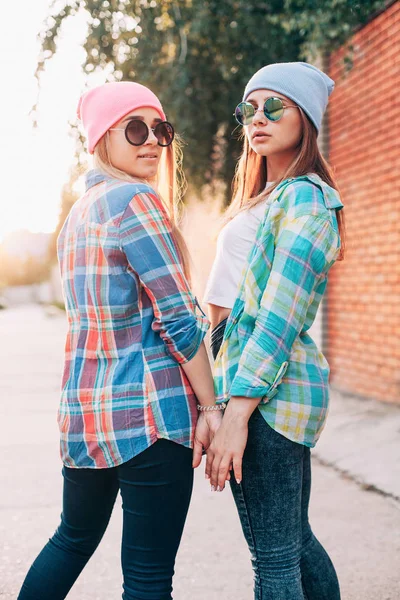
[18,440,193,600]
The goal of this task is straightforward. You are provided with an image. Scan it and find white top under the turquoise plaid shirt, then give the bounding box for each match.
[203,183,272,308]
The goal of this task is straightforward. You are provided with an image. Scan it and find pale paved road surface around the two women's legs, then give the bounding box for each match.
[0,307,400,600]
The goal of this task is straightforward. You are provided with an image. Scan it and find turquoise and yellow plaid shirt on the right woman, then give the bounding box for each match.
[214,175,343,446]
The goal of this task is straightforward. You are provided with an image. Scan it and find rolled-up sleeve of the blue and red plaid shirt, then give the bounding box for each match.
[120,193,209,364]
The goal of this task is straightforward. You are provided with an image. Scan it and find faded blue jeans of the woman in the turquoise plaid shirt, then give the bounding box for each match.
[231,409,340,600]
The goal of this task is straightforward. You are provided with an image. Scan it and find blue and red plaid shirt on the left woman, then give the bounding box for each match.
[57,171,208,468]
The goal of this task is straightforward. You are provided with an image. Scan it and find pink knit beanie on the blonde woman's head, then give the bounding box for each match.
[77,81,166,154]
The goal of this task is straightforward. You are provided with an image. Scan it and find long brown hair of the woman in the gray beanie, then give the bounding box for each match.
[226,109,345,260]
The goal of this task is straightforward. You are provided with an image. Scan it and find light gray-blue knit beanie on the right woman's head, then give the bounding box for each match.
[243,62,335,132]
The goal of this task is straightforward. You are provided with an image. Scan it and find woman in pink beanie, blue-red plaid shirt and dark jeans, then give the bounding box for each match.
[19,82,221,600]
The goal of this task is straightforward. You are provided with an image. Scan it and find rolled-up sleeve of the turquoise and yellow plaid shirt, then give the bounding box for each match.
[230,215,339,402]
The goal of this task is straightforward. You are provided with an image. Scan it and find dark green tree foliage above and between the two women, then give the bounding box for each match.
[38,0,385,199]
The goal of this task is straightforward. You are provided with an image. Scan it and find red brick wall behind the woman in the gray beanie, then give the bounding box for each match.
[327,2,400,403]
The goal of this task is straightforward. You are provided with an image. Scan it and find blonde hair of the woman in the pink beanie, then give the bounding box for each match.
[93,131,190,282]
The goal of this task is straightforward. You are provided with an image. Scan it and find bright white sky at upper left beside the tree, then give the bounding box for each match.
[0,0,91,242]
